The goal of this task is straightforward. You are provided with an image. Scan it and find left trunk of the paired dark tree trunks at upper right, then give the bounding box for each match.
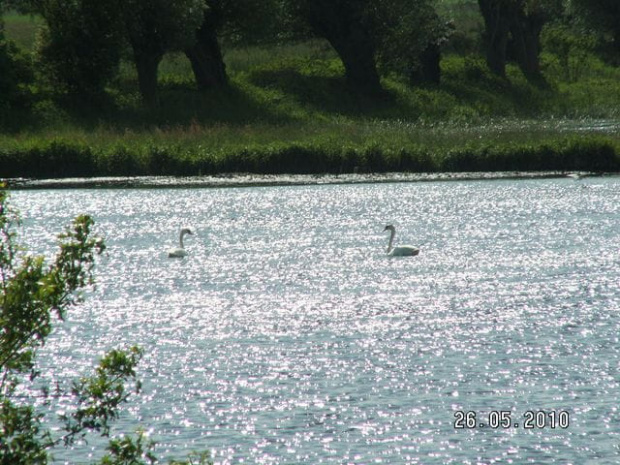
[478,0,514,77]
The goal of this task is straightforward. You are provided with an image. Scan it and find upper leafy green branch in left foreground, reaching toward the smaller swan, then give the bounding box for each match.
[0,202,105,380]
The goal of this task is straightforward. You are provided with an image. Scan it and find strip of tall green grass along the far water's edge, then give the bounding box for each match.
[0,124,620,178]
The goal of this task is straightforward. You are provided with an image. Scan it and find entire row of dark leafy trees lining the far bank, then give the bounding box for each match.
[0,0,620,108]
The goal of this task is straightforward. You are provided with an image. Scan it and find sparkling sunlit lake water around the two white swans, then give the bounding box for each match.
[12,177,620,465]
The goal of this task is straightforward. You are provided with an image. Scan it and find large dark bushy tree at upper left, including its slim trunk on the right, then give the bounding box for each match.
[17,0,206,105]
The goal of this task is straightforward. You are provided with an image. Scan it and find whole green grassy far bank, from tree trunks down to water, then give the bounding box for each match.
[0,14,620,178]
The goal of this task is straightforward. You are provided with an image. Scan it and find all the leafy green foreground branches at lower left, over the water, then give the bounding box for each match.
[0,184,211,465]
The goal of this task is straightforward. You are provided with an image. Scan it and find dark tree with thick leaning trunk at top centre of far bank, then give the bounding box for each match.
[284,0,447,90]
